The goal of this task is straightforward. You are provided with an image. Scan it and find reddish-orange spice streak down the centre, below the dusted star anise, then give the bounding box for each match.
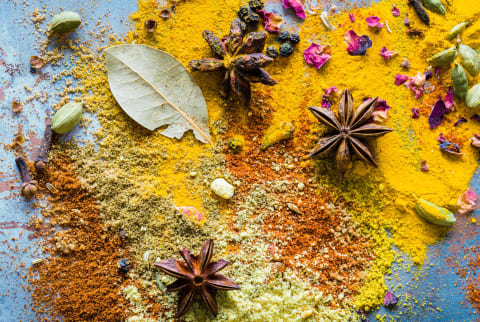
[225,91,374,303]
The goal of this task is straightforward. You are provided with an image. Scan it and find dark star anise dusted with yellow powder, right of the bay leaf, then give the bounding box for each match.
[188,18,277,102]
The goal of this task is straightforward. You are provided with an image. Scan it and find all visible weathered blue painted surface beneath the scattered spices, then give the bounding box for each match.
[0,0,480,321]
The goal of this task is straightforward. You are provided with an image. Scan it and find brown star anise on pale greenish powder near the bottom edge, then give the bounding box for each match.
[154,239,240,317]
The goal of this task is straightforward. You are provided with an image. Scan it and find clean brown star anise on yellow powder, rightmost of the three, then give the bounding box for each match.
[309,89,393,180]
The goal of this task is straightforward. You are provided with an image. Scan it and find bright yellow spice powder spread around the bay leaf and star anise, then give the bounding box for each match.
[68,0,480,309]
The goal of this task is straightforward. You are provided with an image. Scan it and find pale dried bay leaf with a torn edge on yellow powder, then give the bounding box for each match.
[105,45,212,144]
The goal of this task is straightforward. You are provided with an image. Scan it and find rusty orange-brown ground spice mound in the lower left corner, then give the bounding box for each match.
[29,157,133,321]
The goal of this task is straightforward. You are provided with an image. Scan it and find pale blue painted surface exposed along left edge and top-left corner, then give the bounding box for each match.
[0,0,137,322]
